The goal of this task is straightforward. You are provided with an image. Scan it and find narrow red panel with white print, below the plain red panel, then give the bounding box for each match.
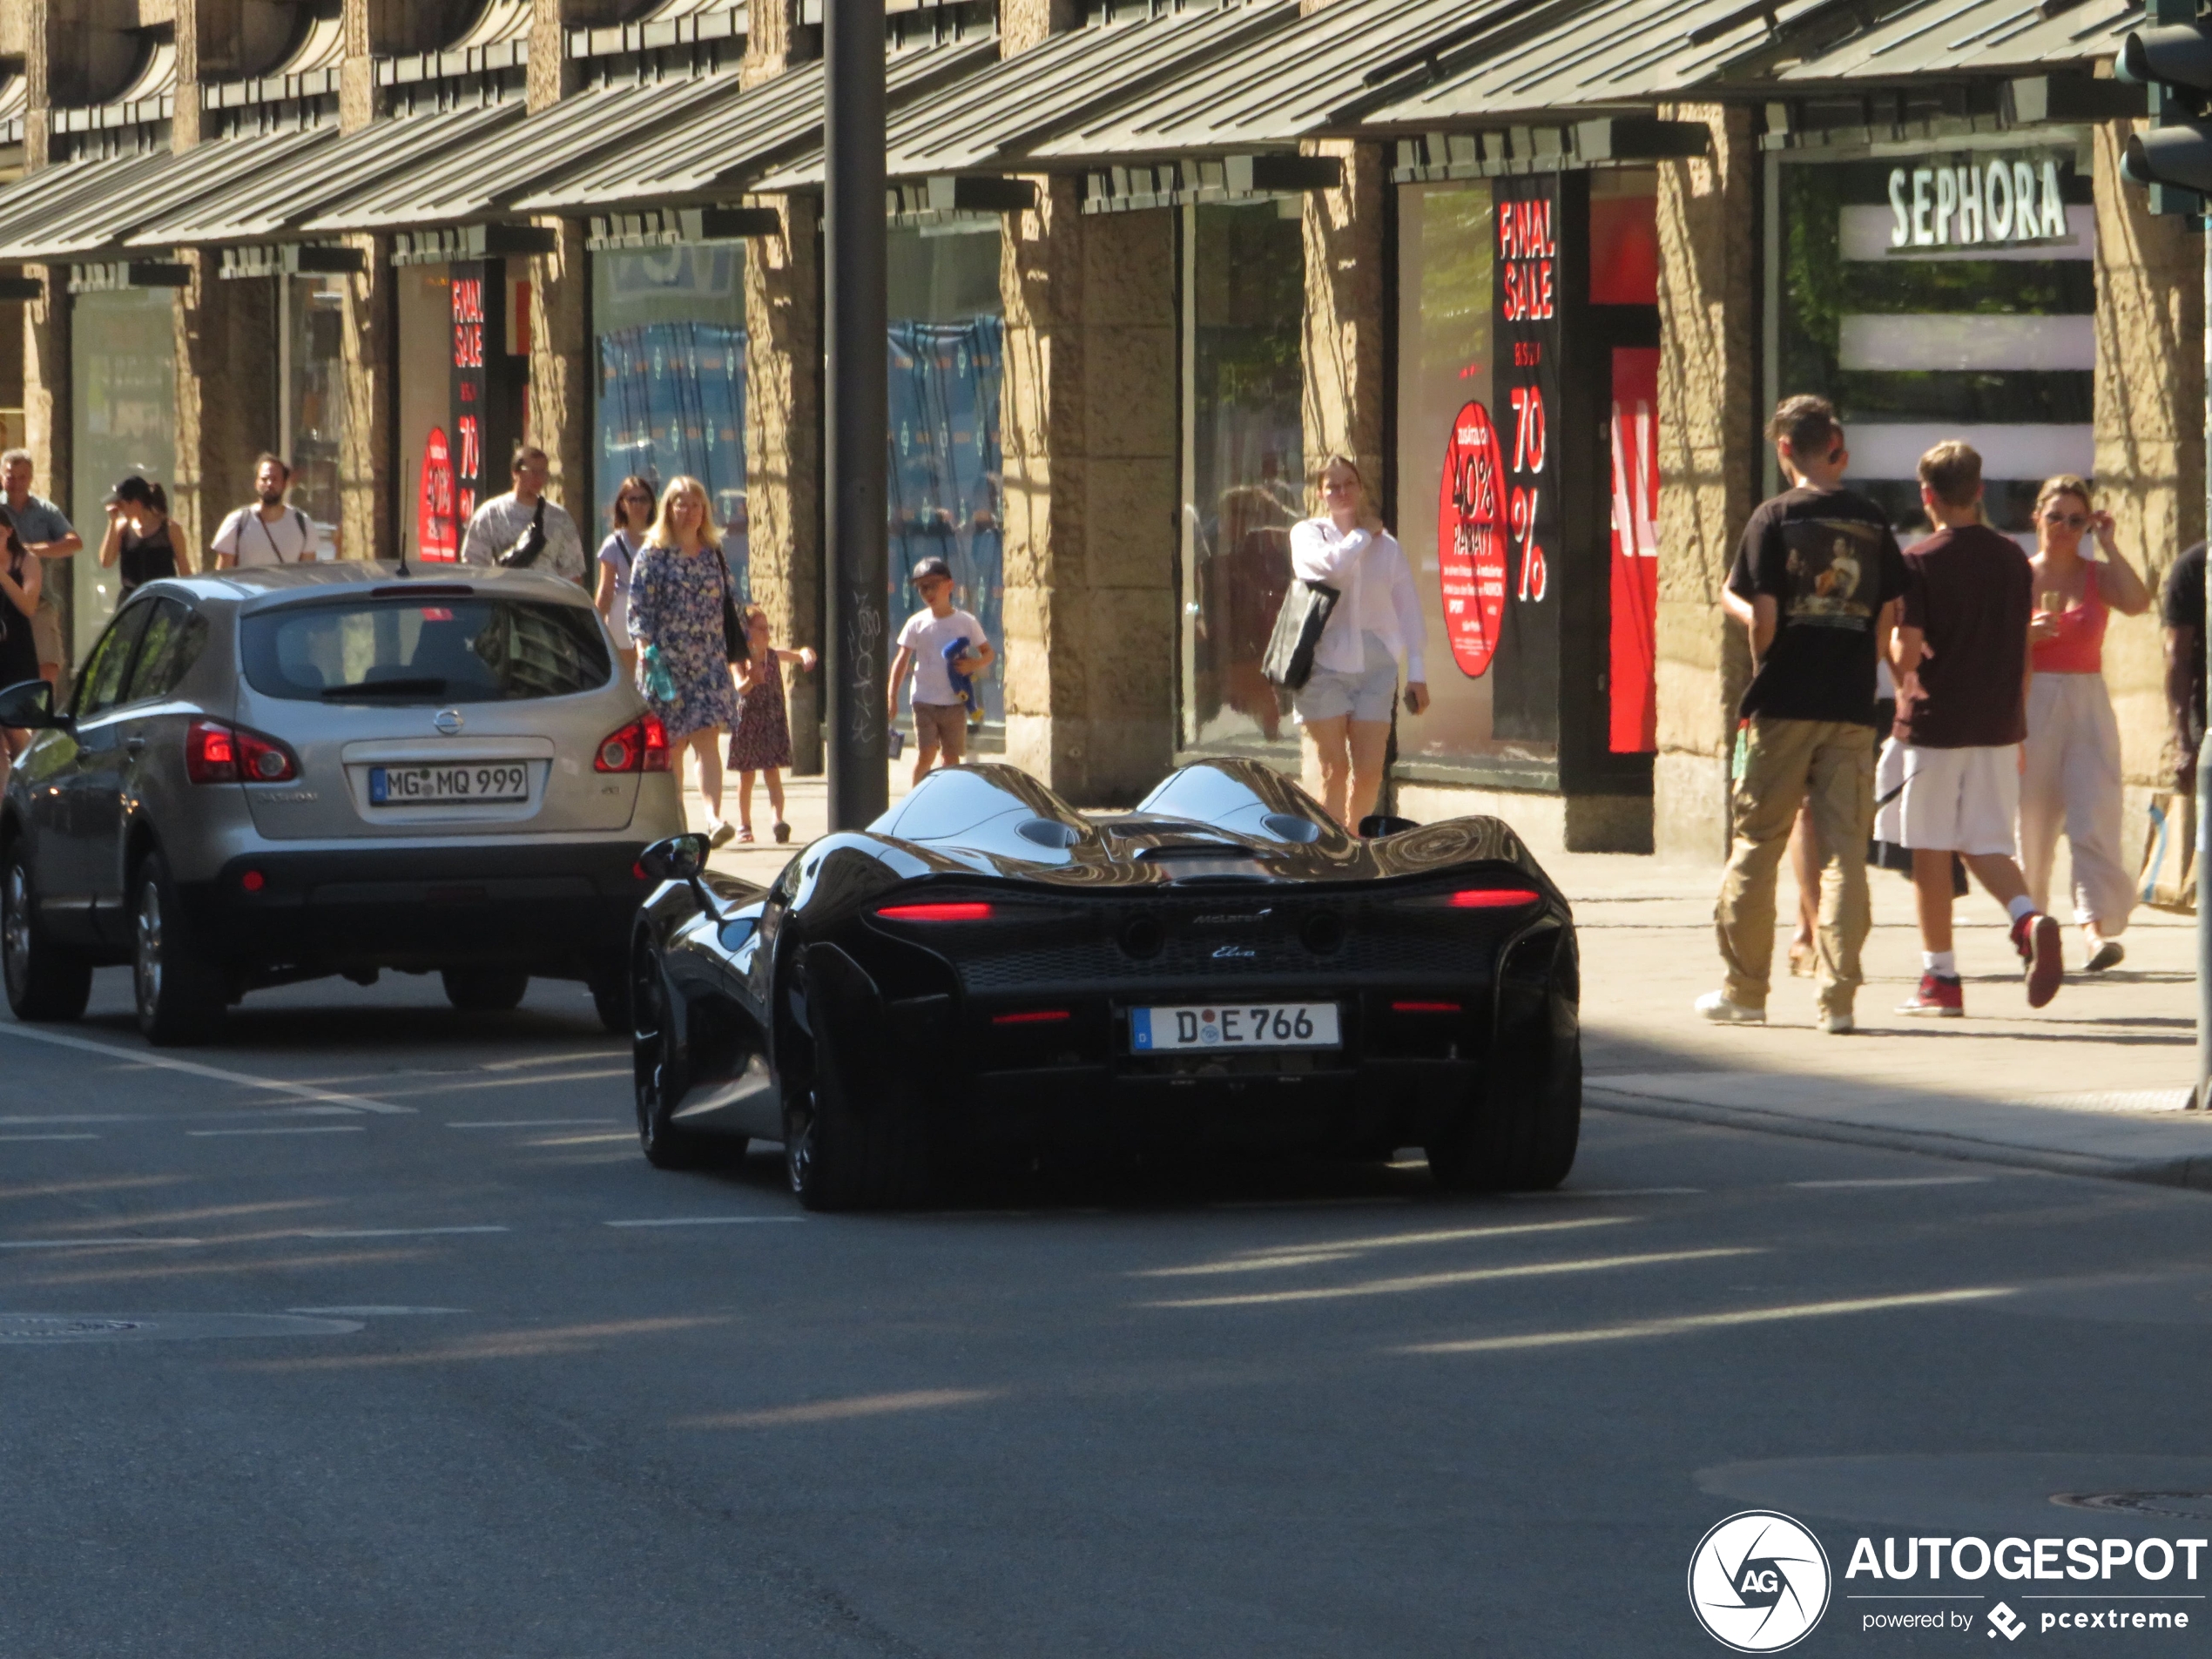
[1606,345,1659,754]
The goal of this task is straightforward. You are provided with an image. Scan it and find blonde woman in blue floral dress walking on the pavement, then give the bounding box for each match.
[628,478,745,847]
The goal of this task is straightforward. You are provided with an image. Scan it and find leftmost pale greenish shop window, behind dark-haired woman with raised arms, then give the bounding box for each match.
[69,287,177,661]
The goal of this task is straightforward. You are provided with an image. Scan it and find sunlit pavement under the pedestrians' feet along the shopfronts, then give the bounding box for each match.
[685,761,2212,1190]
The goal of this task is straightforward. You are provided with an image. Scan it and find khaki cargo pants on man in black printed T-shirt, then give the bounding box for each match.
[1712,714,1873,1013]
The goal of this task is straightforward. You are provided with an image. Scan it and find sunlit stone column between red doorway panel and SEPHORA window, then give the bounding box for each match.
[1652,104,1758,860]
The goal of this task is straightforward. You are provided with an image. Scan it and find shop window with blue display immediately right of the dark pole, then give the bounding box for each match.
[887,217,1007,724]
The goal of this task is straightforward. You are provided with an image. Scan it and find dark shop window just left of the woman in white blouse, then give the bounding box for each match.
[1179,199,1309,767]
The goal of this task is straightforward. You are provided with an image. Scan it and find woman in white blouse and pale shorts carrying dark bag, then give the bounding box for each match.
[1290,455,1429,825]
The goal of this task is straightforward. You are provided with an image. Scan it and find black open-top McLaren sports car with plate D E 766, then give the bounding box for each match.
[632,761,1581,1210]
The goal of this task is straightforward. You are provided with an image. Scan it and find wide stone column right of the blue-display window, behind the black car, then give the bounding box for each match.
[1000,177,1177,806]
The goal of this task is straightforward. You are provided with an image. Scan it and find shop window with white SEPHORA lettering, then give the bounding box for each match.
[1767,142,2097,544]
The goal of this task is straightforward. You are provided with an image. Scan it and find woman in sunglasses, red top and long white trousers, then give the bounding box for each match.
[2020,474,2150,974]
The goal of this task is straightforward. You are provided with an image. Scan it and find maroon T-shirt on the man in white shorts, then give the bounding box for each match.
[1896,524,2035,750]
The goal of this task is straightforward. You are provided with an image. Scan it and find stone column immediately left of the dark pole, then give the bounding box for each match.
[745,197,823,774]
